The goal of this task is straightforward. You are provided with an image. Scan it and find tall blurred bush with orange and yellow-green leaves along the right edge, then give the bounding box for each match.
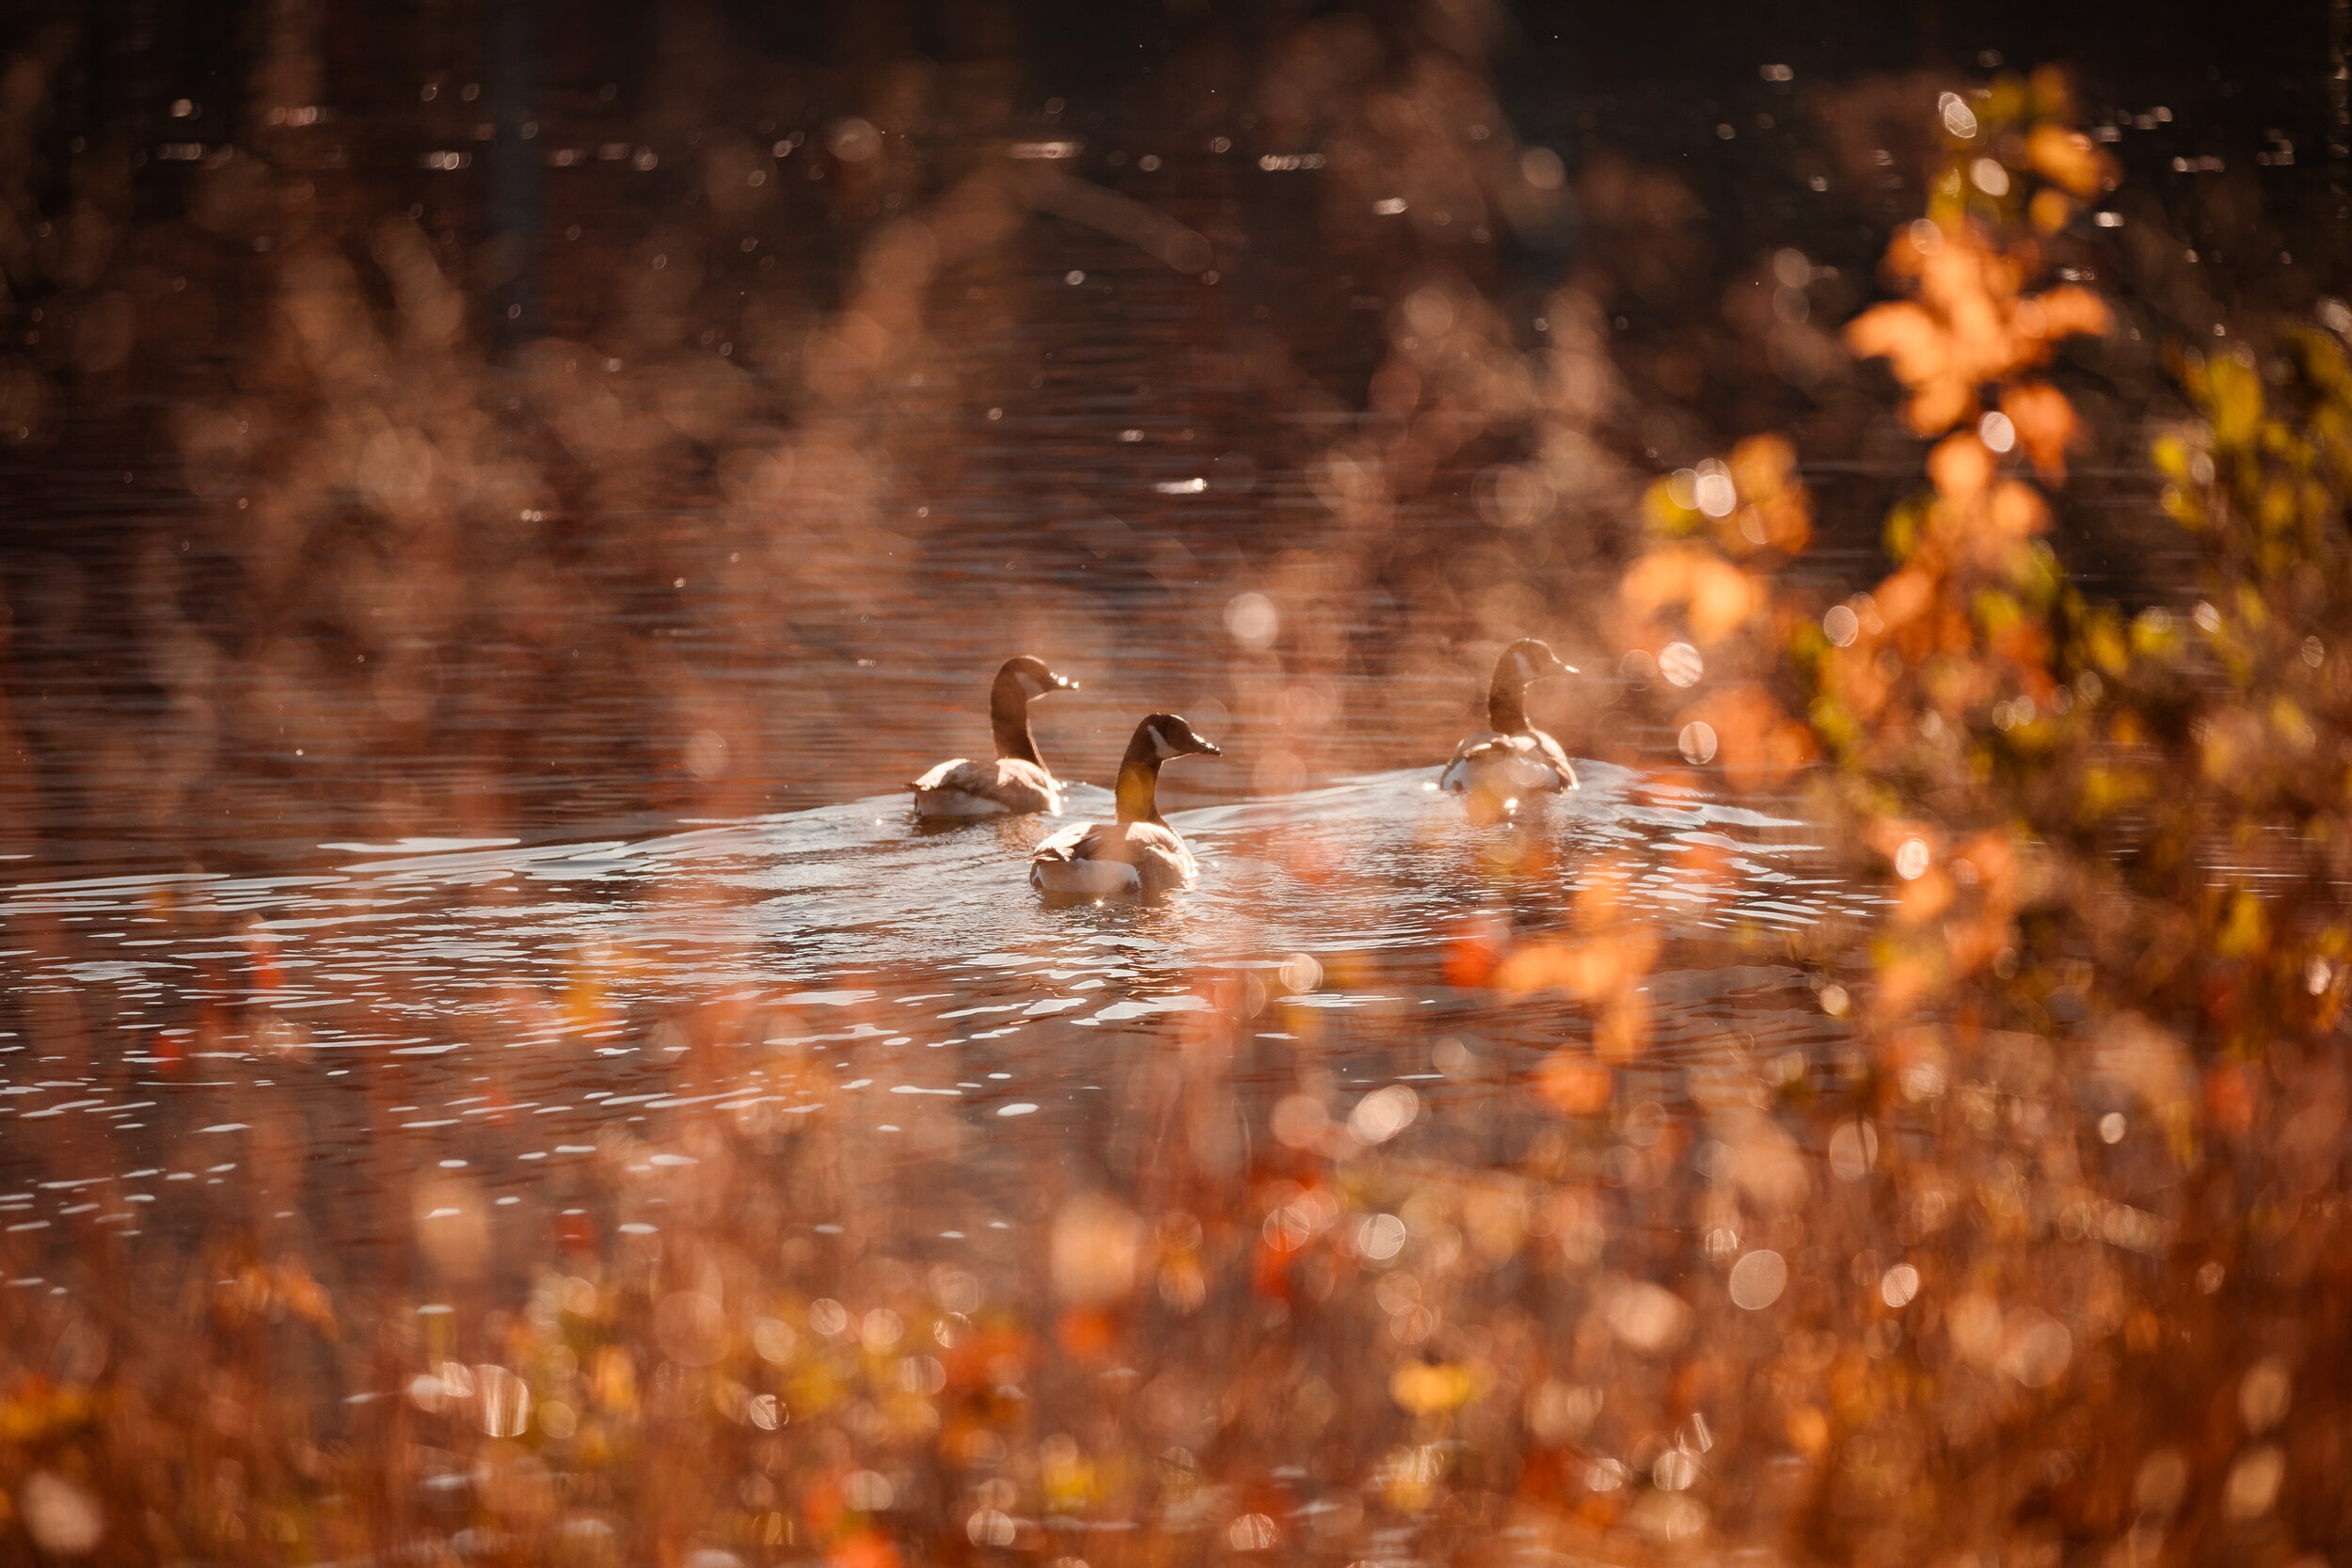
[1623,72,2352,1561]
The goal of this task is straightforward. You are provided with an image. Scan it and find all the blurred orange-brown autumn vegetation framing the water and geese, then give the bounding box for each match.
[0,6,2352,1568]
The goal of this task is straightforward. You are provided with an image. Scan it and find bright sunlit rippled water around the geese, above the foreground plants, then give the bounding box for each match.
[0,764,1875,1281]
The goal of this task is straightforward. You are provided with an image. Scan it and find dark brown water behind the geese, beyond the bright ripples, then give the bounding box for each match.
[0,7,2343,870]
